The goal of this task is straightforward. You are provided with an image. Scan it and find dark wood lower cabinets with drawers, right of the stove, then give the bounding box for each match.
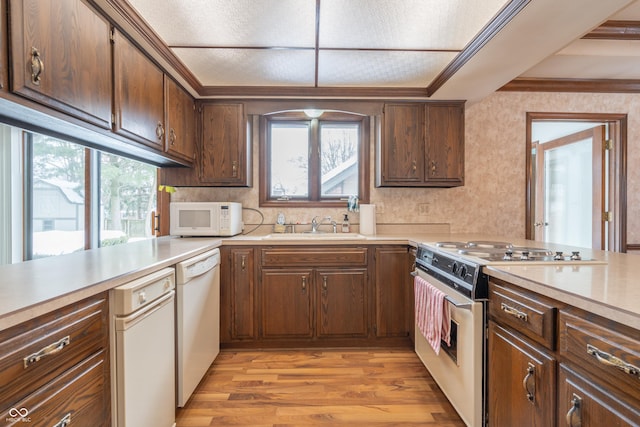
[487,279,640,427]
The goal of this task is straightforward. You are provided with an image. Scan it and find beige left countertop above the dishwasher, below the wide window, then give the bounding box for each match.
[0,237,221,330]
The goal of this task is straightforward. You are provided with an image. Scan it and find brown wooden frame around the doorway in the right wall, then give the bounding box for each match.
[525,112,627,252]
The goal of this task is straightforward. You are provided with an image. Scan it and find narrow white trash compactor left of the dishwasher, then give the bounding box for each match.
[110,268,176,427]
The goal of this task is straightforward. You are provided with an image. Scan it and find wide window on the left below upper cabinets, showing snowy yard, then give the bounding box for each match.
[0,124,157,264]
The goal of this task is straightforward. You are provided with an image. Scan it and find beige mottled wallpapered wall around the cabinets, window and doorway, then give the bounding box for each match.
[172,92,640,244]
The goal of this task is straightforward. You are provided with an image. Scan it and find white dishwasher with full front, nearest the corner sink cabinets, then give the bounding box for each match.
[176,249,220,407]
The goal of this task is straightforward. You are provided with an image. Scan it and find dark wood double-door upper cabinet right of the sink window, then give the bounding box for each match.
[376,102,464,187]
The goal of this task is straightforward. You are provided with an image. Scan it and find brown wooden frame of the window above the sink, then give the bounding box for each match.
[259,111,371,207]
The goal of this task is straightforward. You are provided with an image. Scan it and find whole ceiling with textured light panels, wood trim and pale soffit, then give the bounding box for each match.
[104,0,640,101]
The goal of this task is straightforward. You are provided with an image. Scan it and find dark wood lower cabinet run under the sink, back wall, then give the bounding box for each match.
[220,244,413,348]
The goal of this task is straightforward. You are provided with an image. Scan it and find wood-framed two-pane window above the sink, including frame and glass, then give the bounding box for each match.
[260,112,369,206]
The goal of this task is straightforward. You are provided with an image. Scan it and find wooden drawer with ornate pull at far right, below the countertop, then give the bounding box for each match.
[559,309,640,399]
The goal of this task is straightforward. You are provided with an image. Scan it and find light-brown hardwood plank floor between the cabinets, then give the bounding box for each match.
[177,349,464,427]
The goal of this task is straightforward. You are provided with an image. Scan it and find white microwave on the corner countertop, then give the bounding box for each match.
[169,202,242,236]
